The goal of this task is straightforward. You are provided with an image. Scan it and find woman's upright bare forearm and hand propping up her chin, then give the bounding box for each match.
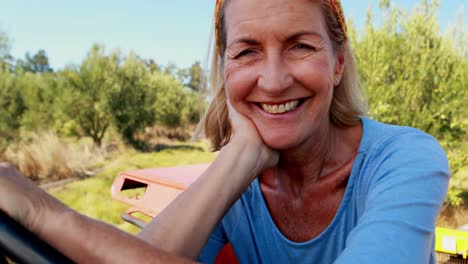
[138,103,278,259]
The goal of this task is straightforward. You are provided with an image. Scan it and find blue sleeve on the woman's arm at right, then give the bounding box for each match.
[335,131,450,264]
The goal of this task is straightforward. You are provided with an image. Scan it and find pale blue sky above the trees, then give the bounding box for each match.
[0,0,468,69]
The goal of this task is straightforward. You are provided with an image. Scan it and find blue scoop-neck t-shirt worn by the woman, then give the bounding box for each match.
[199,118,450,264]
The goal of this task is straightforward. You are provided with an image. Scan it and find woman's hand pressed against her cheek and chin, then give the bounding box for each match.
[226,99,279,180]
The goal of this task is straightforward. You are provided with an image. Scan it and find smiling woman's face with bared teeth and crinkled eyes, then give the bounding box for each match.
[224,0,344,149]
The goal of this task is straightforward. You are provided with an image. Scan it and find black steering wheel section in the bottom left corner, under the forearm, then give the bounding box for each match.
[0,211,73,264]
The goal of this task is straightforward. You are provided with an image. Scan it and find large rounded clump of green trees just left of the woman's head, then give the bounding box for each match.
[58,45,204,148]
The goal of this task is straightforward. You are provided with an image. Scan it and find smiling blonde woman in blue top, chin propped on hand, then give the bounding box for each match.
[0,0,449,263]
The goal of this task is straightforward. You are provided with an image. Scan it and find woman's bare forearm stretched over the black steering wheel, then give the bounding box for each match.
[0,163,190,263]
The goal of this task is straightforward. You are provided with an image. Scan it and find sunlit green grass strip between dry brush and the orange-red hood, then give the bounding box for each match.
[49,143,215,233]
